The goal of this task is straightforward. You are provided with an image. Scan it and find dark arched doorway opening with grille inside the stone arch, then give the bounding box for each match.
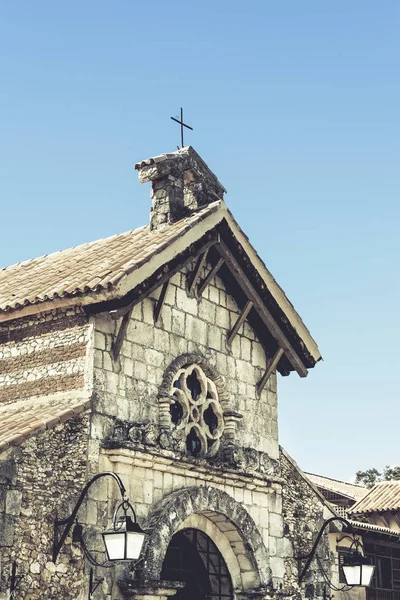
[161,529,233,600]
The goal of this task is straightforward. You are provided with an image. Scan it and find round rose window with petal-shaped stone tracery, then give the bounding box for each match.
[170,365,224,457]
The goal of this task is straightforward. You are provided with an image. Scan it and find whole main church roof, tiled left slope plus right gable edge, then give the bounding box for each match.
[0,200,321,368]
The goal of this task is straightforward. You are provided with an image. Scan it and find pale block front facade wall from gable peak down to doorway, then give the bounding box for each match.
[84,270,285,598]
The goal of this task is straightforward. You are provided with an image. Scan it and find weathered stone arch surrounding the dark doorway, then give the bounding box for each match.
[137,486,271,593]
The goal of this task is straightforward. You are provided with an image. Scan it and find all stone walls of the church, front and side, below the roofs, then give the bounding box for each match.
[0,260,322,600]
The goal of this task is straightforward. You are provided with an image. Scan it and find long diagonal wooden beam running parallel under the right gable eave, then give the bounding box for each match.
[216,241,308,377]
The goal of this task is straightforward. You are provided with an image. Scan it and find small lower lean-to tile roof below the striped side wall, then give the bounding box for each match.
[0,391,90,452]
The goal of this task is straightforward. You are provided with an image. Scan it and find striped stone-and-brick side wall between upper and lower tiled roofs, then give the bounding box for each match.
[0,309,89,404]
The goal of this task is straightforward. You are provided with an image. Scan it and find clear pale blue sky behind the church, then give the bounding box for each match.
[0,0,400,479]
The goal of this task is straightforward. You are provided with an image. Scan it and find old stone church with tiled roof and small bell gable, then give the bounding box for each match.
[0,147,335,600]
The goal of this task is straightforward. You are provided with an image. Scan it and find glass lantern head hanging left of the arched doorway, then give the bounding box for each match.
[103,500,146,561]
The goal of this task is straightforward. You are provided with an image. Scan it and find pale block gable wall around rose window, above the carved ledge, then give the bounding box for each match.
[94,264,279,460]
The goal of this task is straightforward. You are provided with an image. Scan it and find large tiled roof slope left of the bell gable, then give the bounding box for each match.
[0,202,219,312]
